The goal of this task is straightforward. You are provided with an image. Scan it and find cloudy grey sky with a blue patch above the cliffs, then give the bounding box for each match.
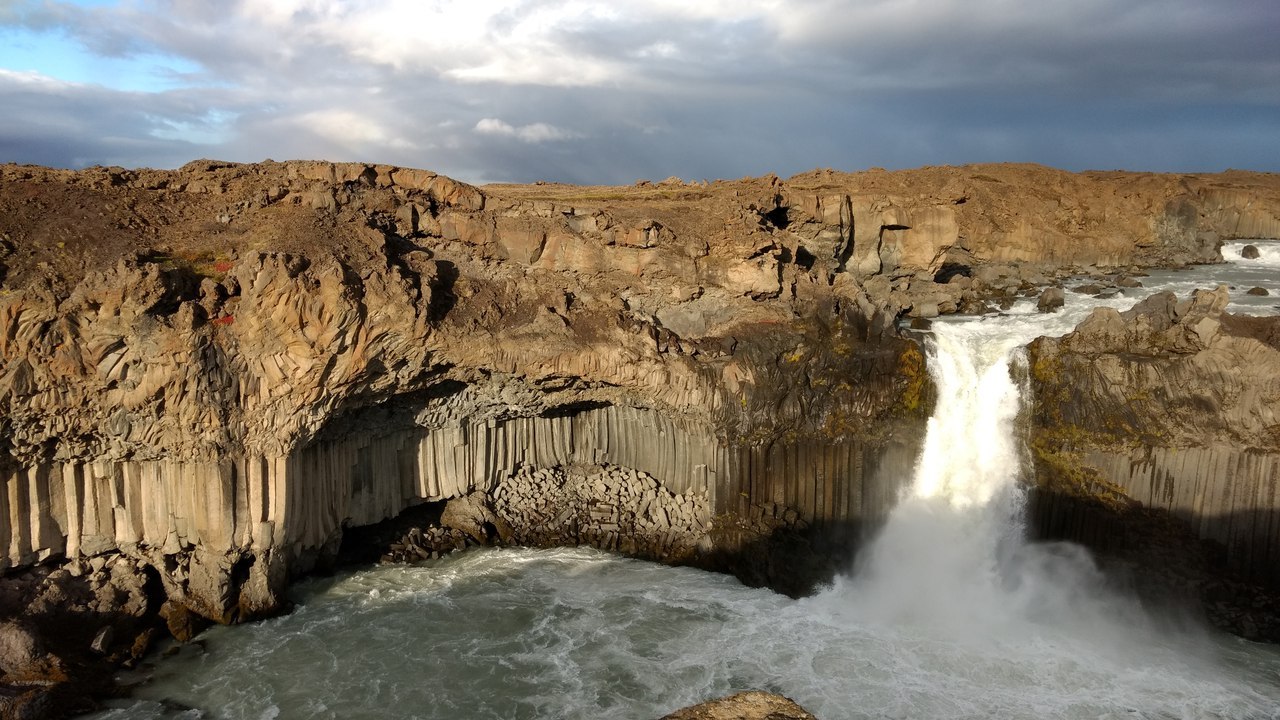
[0,0,1280,183]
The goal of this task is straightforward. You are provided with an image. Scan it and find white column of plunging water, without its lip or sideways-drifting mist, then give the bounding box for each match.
[834,318,1044,630]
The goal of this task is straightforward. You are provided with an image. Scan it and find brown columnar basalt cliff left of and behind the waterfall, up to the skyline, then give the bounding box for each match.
[0,161,1280,712]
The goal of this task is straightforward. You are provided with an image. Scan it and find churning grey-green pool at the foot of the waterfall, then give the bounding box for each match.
[94,550,1280,720]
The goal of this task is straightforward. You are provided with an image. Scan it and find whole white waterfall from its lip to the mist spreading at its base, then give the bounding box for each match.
[836,302,1167,643]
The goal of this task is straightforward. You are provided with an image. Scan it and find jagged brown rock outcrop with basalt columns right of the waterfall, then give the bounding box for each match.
[1030,287,1280,639]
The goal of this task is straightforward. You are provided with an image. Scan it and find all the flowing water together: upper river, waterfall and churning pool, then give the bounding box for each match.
[87,246,1280,720]
